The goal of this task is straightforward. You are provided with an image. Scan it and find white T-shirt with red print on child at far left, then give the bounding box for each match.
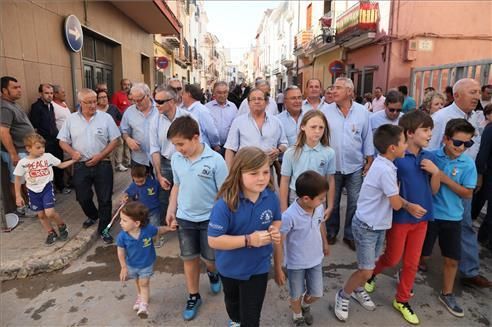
[14,153,61,193]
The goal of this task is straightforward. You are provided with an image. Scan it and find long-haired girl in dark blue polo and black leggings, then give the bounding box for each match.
[208,147,281,326]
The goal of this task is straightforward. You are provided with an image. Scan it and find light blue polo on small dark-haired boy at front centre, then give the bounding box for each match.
[280,201,324,269]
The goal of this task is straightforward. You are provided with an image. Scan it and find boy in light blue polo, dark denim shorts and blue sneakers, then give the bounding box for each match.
[166,116,227,320]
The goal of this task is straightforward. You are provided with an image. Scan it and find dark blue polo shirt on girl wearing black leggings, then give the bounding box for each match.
[208,189,281,280]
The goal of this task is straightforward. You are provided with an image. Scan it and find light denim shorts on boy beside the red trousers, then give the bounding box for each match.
[352,216,386,270]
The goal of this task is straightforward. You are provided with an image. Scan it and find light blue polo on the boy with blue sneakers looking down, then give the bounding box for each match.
[171,143,227,222]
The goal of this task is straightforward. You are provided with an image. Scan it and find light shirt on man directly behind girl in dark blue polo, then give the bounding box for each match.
[224,113,287,152]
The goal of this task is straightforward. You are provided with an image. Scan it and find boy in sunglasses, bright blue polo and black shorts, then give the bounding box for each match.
[422,118,477,317]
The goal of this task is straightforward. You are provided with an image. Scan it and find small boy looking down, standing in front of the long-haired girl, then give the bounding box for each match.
[276,170,329,326]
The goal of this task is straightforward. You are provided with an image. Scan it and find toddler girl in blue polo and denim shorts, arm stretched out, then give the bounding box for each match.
[116,201,176,318]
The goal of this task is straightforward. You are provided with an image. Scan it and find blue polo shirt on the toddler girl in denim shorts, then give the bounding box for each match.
[116,224,157,268]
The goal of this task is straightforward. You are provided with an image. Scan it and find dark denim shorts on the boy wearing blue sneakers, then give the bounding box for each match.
[177,218,215,262]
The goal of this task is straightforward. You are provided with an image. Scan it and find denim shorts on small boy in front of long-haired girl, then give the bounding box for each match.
[287,263,323,300]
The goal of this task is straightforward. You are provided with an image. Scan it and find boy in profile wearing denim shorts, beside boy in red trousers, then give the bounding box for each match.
[334,124,426,321]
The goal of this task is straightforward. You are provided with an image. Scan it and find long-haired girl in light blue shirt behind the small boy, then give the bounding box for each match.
[280,110,335,217]
